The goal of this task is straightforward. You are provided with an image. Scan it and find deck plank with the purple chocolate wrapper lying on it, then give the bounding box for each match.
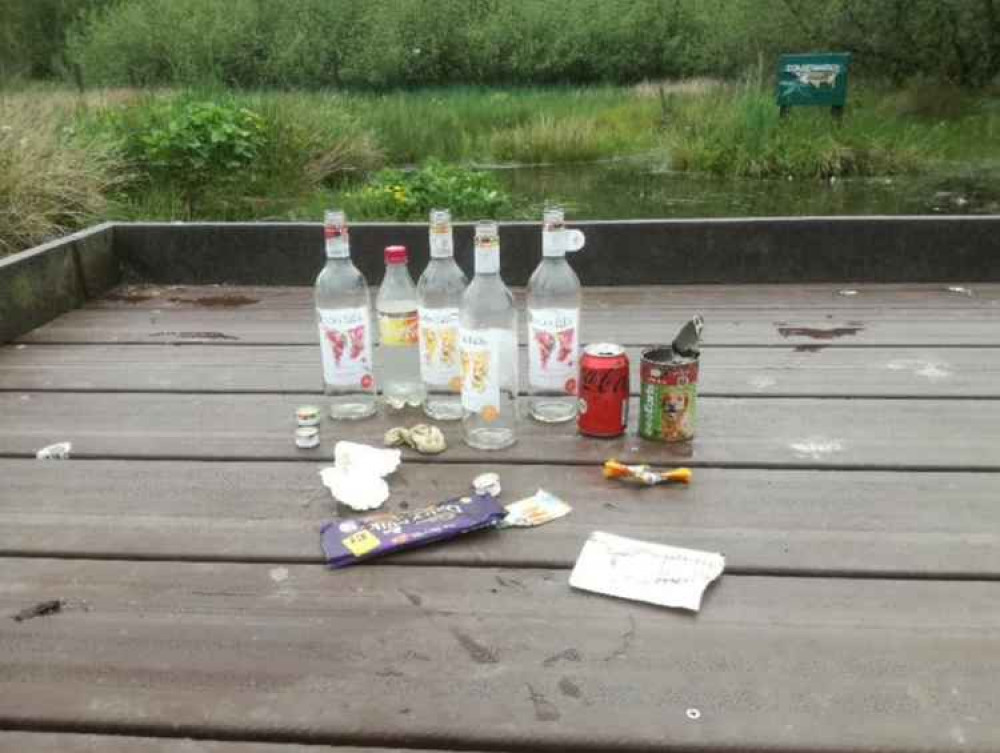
[0,460,1000,579]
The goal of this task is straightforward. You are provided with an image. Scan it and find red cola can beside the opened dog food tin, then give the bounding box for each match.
[576,343,629,437]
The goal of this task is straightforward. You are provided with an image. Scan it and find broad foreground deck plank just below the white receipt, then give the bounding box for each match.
[0,560,1000,753]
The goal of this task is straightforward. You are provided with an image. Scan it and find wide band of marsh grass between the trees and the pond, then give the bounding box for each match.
[0,82,1000,253]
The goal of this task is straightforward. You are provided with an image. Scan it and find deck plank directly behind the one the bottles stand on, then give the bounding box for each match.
[0,345,1000,398]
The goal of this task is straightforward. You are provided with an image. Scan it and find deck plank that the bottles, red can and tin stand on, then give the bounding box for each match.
[0,392,1000,470]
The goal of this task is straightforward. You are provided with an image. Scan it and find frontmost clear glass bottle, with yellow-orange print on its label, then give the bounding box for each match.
[459,221,517,450]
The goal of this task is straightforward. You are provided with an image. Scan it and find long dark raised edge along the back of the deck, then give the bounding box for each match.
[115,216,1000,285]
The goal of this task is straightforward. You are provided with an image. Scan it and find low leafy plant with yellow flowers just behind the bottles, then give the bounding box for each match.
[342,162,510,221]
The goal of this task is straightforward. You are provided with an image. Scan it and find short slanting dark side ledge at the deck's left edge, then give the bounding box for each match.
[0,224,121,343]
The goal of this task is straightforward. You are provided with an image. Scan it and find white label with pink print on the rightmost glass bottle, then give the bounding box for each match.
[528,309,580,395]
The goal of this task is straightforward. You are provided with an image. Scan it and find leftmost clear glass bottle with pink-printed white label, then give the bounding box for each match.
[315,210,375,419]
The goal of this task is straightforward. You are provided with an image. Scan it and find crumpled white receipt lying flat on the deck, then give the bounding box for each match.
[569,531,726,612]
